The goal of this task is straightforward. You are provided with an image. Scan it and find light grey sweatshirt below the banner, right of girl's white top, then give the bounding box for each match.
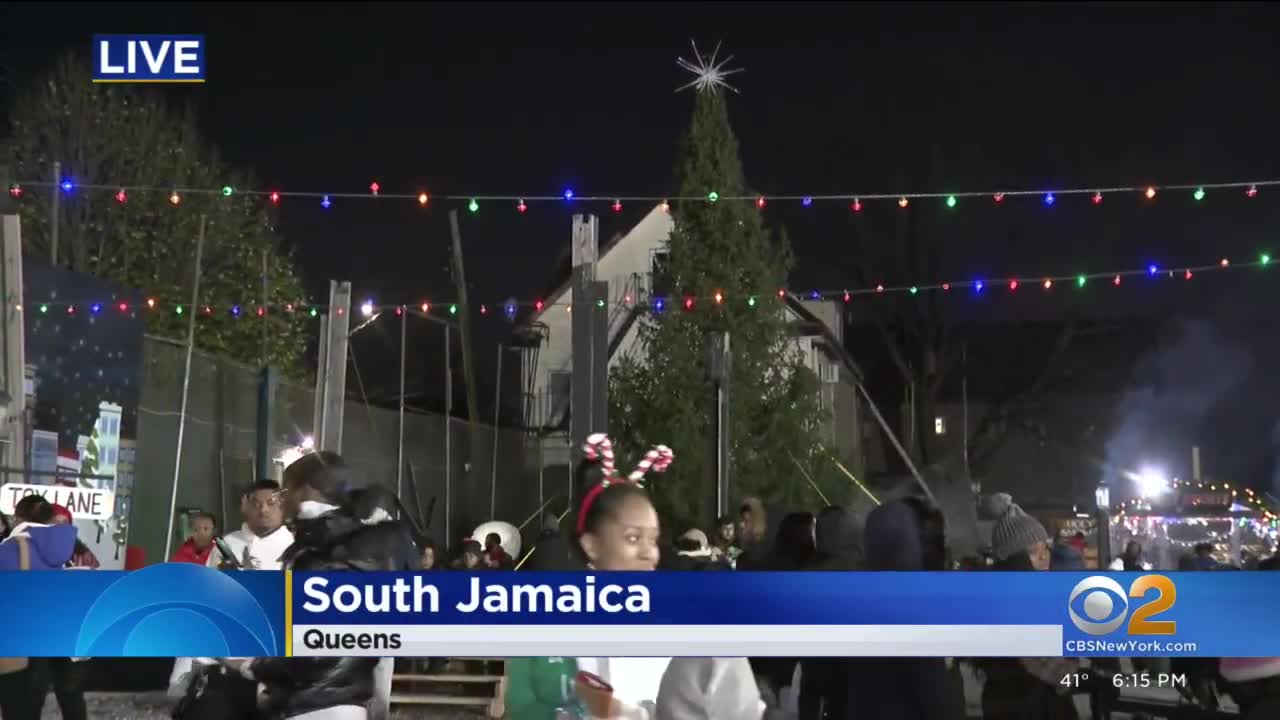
[657,657,765,720]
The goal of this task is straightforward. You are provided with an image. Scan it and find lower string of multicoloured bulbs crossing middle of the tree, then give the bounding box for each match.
[17,254,1272,319]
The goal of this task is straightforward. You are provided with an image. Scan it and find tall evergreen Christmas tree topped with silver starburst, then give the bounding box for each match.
[609,46,822,530]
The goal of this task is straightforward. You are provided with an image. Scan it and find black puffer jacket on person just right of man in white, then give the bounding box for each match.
[252,491,421,717]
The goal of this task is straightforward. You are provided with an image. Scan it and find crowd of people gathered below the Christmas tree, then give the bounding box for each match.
[0,436,1280,720]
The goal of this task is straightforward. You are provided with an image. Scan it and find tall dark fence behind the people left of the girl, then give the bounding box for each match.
[129,337,550,562]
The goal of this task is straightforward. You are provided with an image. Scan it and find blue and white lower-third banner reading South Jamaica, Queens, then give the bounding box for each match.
[0,564,1280,657]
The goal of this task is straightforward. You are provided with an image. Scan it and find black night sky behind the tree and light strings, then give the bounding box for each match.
[0,3,1280,486]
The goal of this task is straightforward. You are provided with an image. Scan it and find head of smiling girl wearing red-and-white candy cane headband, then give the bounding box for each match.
[576,433,675,570]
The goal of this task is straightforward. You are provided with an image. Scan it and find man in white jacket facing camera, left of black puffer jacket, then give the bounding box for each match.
[169,480,293,697]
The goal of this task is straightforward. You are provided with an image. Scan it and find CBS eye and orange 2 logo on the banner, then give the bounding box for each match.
[1066,575,1178,635]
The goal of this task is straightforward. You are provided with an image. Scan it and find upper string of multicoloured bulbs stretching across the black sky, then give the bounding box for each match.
[9,177,1280,213]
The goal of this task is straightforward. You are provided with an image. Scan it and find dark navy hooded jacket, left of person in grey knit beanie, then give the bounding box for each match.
[845,500,964,720]
